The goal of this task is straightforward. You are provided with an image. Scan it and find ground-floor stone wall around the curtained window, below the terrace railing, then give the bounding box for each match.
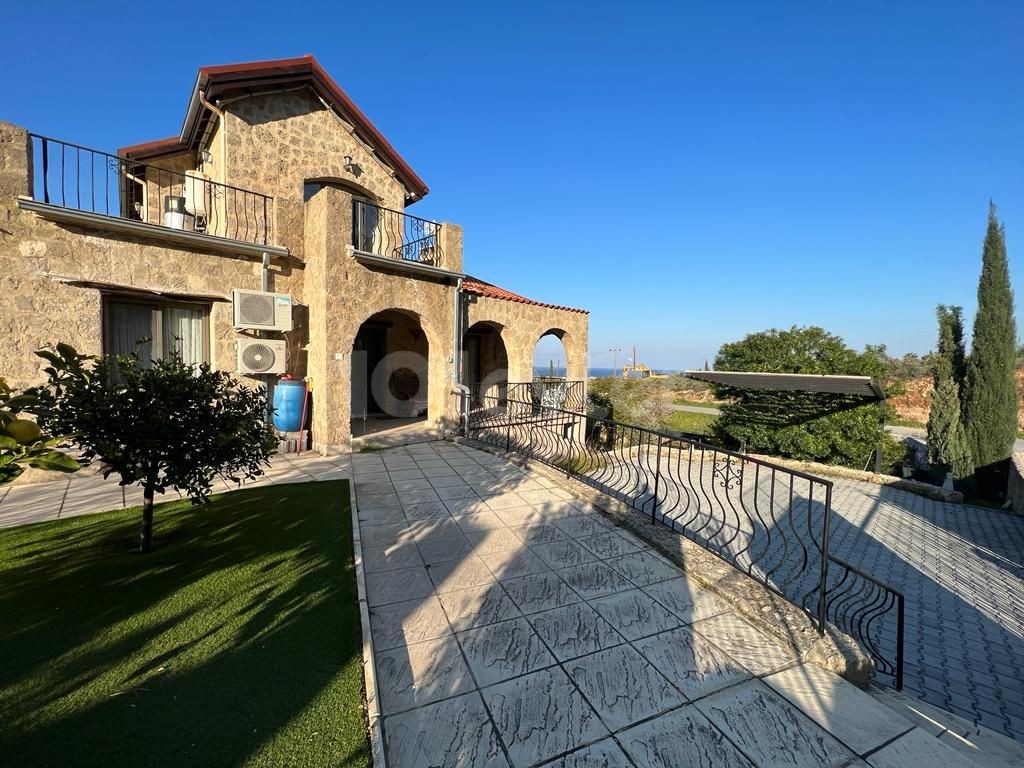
[0,123,302,387]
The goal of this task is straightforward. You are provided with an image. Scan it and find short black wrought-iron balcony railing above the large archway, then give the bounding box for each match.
[352,200,444,268]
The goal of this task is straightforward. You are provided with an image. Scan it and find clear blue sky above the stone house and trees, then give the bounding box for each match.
[0,0,1024,369]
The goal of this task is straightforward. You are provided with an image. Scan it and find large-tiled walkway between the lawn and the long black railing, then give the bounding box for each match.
[352,442,968,768]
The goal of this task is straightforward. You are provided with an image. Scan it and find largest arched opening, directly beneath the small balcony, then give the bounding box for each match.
[351,309,430,437]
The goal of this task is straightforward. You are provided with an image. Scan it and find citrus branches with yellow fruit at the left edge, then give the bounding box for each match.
[0,378,79,485]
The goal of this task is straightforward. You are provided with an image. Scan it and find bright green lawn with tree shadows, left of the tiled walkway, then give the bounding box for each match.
[0,480,370,768]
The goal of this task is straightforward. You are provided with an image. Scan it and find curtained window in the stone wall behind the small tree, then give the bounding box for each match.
[103,297,210,365]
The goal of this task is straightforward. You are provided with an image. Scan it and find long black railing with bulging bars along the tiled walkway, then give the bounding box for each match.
[460,385,903,687]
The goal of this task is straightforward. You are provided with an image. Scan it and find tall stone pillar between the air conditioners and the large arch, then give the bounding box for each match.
[303,187,354,455]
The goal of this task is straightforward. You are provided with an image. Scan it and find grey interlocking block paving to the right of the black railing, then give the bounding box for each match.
[829,480,1024,741]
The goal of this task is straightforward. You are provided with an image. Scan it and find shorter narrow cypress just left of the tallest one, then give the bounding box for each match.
[928,304,974,480]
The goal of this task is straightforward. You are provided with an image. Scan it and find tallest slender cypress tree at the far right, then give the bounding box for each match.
[963,204,1017,467]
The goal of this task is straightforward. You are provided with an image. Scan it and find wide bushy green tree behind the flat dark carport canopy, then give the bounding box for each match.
[713,327,903,469]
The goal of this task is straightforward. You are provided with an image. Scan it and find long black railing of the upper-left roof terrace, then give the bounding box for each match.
[29,133,273,245]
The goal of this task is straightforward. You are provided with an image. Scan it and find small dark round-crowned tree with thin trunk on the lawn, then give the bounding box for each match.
[34,344,275,552]
